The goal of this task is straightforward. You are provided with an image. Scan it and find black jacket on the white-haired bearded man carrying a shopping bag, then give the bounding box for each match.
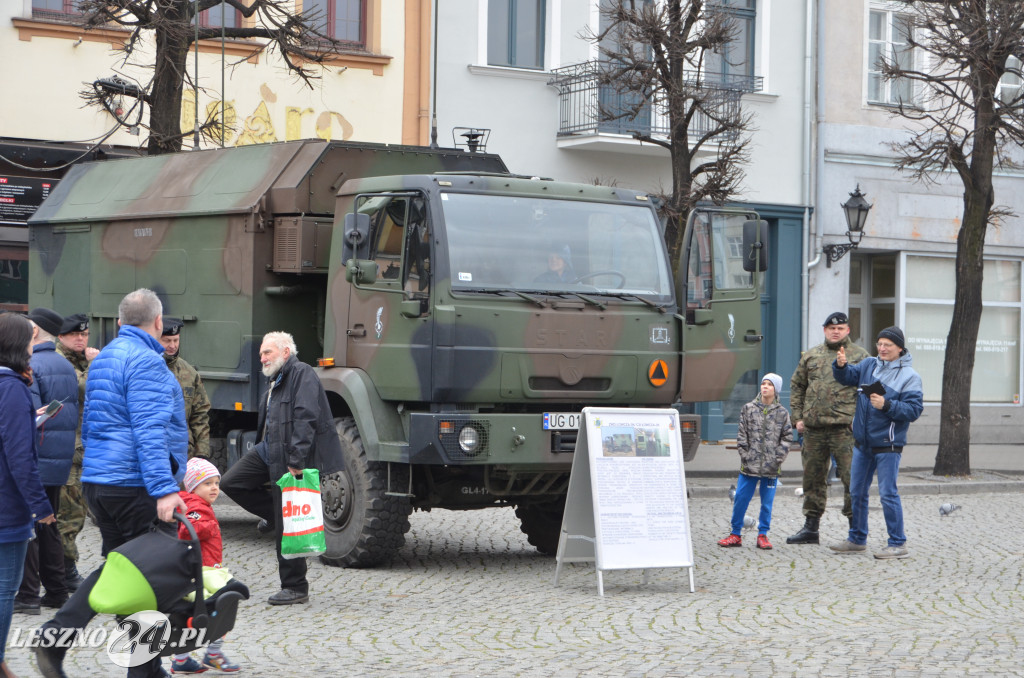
[256,355,344,481]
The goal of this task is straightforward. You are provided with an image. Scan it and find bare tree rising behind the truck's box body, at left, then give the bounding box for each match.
[76,0,352,155]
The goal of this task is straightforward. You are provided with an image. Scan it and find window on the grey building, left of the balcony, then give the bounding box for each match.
[487,0,546,70]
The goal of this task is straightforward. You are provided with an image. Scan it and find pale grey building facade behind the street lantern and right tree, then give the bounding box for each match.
[806,0,1024,443]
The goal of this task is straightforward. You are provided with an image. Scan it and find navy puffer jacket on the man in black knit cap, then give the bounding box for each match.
[30,341,78,486]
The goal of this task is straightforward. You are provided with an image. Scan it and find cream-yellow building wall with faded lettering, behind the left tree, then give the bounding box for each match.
[0,0,421,147]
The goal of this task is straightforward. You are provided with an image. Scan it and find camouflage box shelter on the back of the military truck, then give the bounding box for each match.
[30,140,507,419]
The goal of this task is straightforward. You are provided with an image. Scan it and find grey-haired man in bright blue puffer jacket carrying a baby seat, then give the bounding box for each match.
[35,289,188,677]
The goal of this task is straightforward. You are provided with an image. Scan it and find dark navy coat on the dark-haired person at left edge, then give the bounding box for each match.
[0,368,53,544]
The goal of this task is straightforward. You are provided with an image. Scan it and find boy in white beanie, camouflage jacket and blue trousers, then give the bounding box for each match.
[718,372,793,549]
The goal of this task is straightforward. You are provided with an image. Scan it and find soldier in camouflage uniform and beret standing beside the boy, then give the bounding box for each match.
[785,311,868,544]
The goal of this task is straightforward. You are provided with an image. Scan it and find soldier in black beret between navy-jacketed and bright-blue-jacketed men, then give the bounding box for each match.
[57,313,99,591]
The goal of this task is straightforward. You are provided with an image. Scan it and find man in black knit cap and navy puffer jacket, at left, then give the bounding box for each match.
[14,308,78,615]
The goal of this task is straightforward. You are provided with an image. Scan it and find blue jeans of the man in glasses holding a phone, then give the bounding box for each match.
[849,447,906,546]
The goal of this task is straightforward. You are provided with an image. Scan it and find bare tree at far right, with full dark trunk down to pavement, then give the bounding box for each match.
[882,0,1024,475]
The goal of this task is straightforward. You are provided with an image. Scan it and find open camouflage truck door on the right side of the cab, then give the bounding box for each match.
[677,209,763,402]
